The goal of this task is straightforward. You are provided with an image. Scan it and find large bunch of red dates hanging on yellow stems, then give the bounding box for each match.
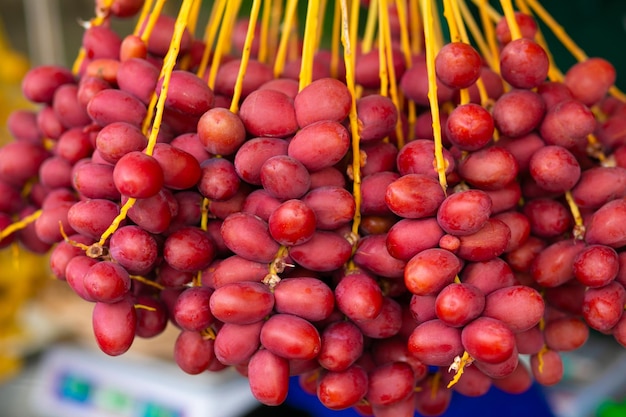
[0,0,626,417]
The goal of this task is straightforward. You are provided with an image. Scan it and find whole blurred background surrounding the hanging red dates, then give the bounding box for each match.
[0,0,626,417]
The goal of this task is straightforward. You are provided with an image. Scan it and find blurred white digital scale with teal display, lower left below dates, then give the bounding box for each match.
[30,347,258,417]
